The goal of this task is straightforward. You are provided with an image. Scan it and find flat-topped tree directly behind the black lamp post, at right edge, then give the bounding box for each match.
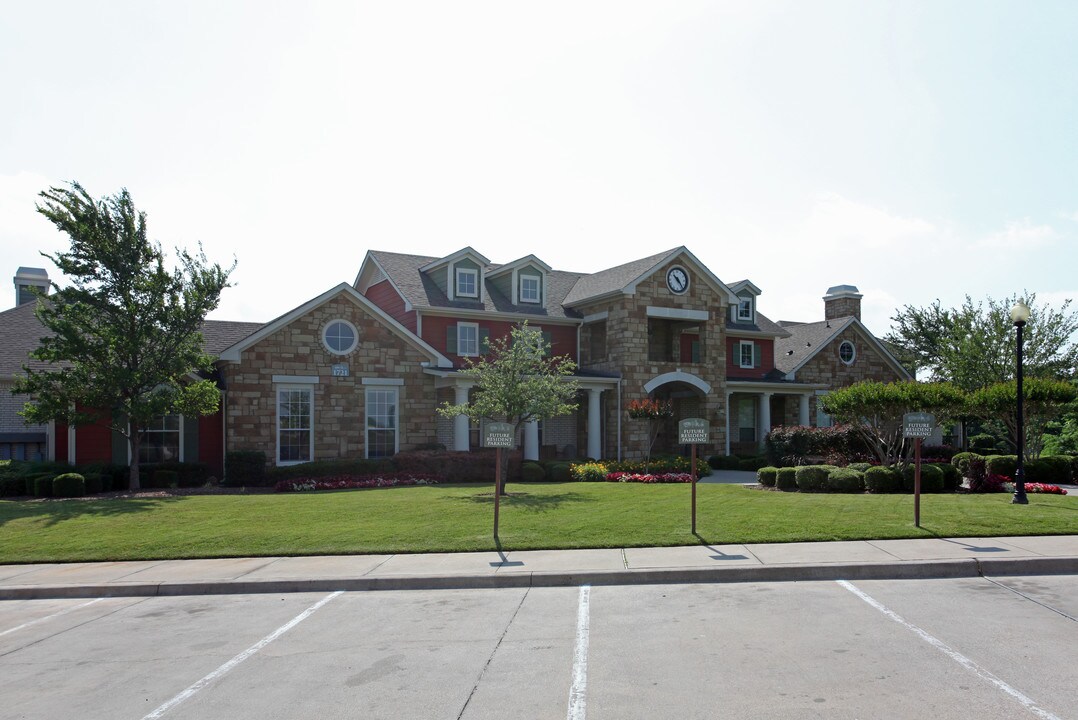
[969,377,1078,458]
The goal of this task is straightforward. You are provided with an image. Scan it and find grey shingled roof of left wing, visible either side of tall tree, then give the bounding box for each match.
[0,303,262,380]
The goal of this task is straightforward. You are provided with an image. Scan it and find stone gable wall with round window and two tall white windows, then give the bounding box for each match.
[223,294,438,465]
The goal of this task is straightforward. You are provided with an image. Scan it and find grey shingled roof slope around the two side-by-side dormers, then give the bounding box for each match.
[357,250,581,319]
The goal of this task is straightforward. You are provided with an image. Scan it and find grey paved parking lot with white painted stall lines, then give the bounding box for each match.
[0,576,1078,720]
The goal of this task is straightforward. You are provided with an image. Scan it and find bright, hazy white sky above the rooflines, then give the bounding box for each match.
[0,0,1078,336]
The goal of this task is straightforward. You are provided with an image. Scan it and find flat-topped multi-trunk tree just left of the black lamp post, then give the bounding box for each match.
[820,380,966,465]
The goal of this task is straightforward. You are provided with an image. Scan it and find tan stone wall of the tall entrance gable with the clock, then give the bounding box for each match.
[577,262,728,458]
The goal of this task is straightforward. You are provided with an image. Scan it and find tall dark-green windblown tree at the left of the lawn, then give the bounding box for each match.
[13,183,235,489]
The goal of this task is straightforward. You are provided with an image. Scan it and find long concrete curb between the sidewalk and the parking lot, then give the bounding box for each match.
[0,557,1078,600]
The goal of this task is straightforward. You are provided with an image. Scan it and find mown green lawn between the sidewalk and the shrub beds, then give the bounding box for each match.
[0,483,1078,564]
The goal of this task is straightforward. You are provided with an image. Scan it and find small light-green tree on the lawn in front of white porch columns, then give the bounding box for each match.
[438,321,579,491]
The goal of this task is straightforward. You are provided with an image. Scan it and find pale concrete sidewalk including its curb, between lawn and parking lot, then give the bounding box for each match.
[0,536,1078,600]
